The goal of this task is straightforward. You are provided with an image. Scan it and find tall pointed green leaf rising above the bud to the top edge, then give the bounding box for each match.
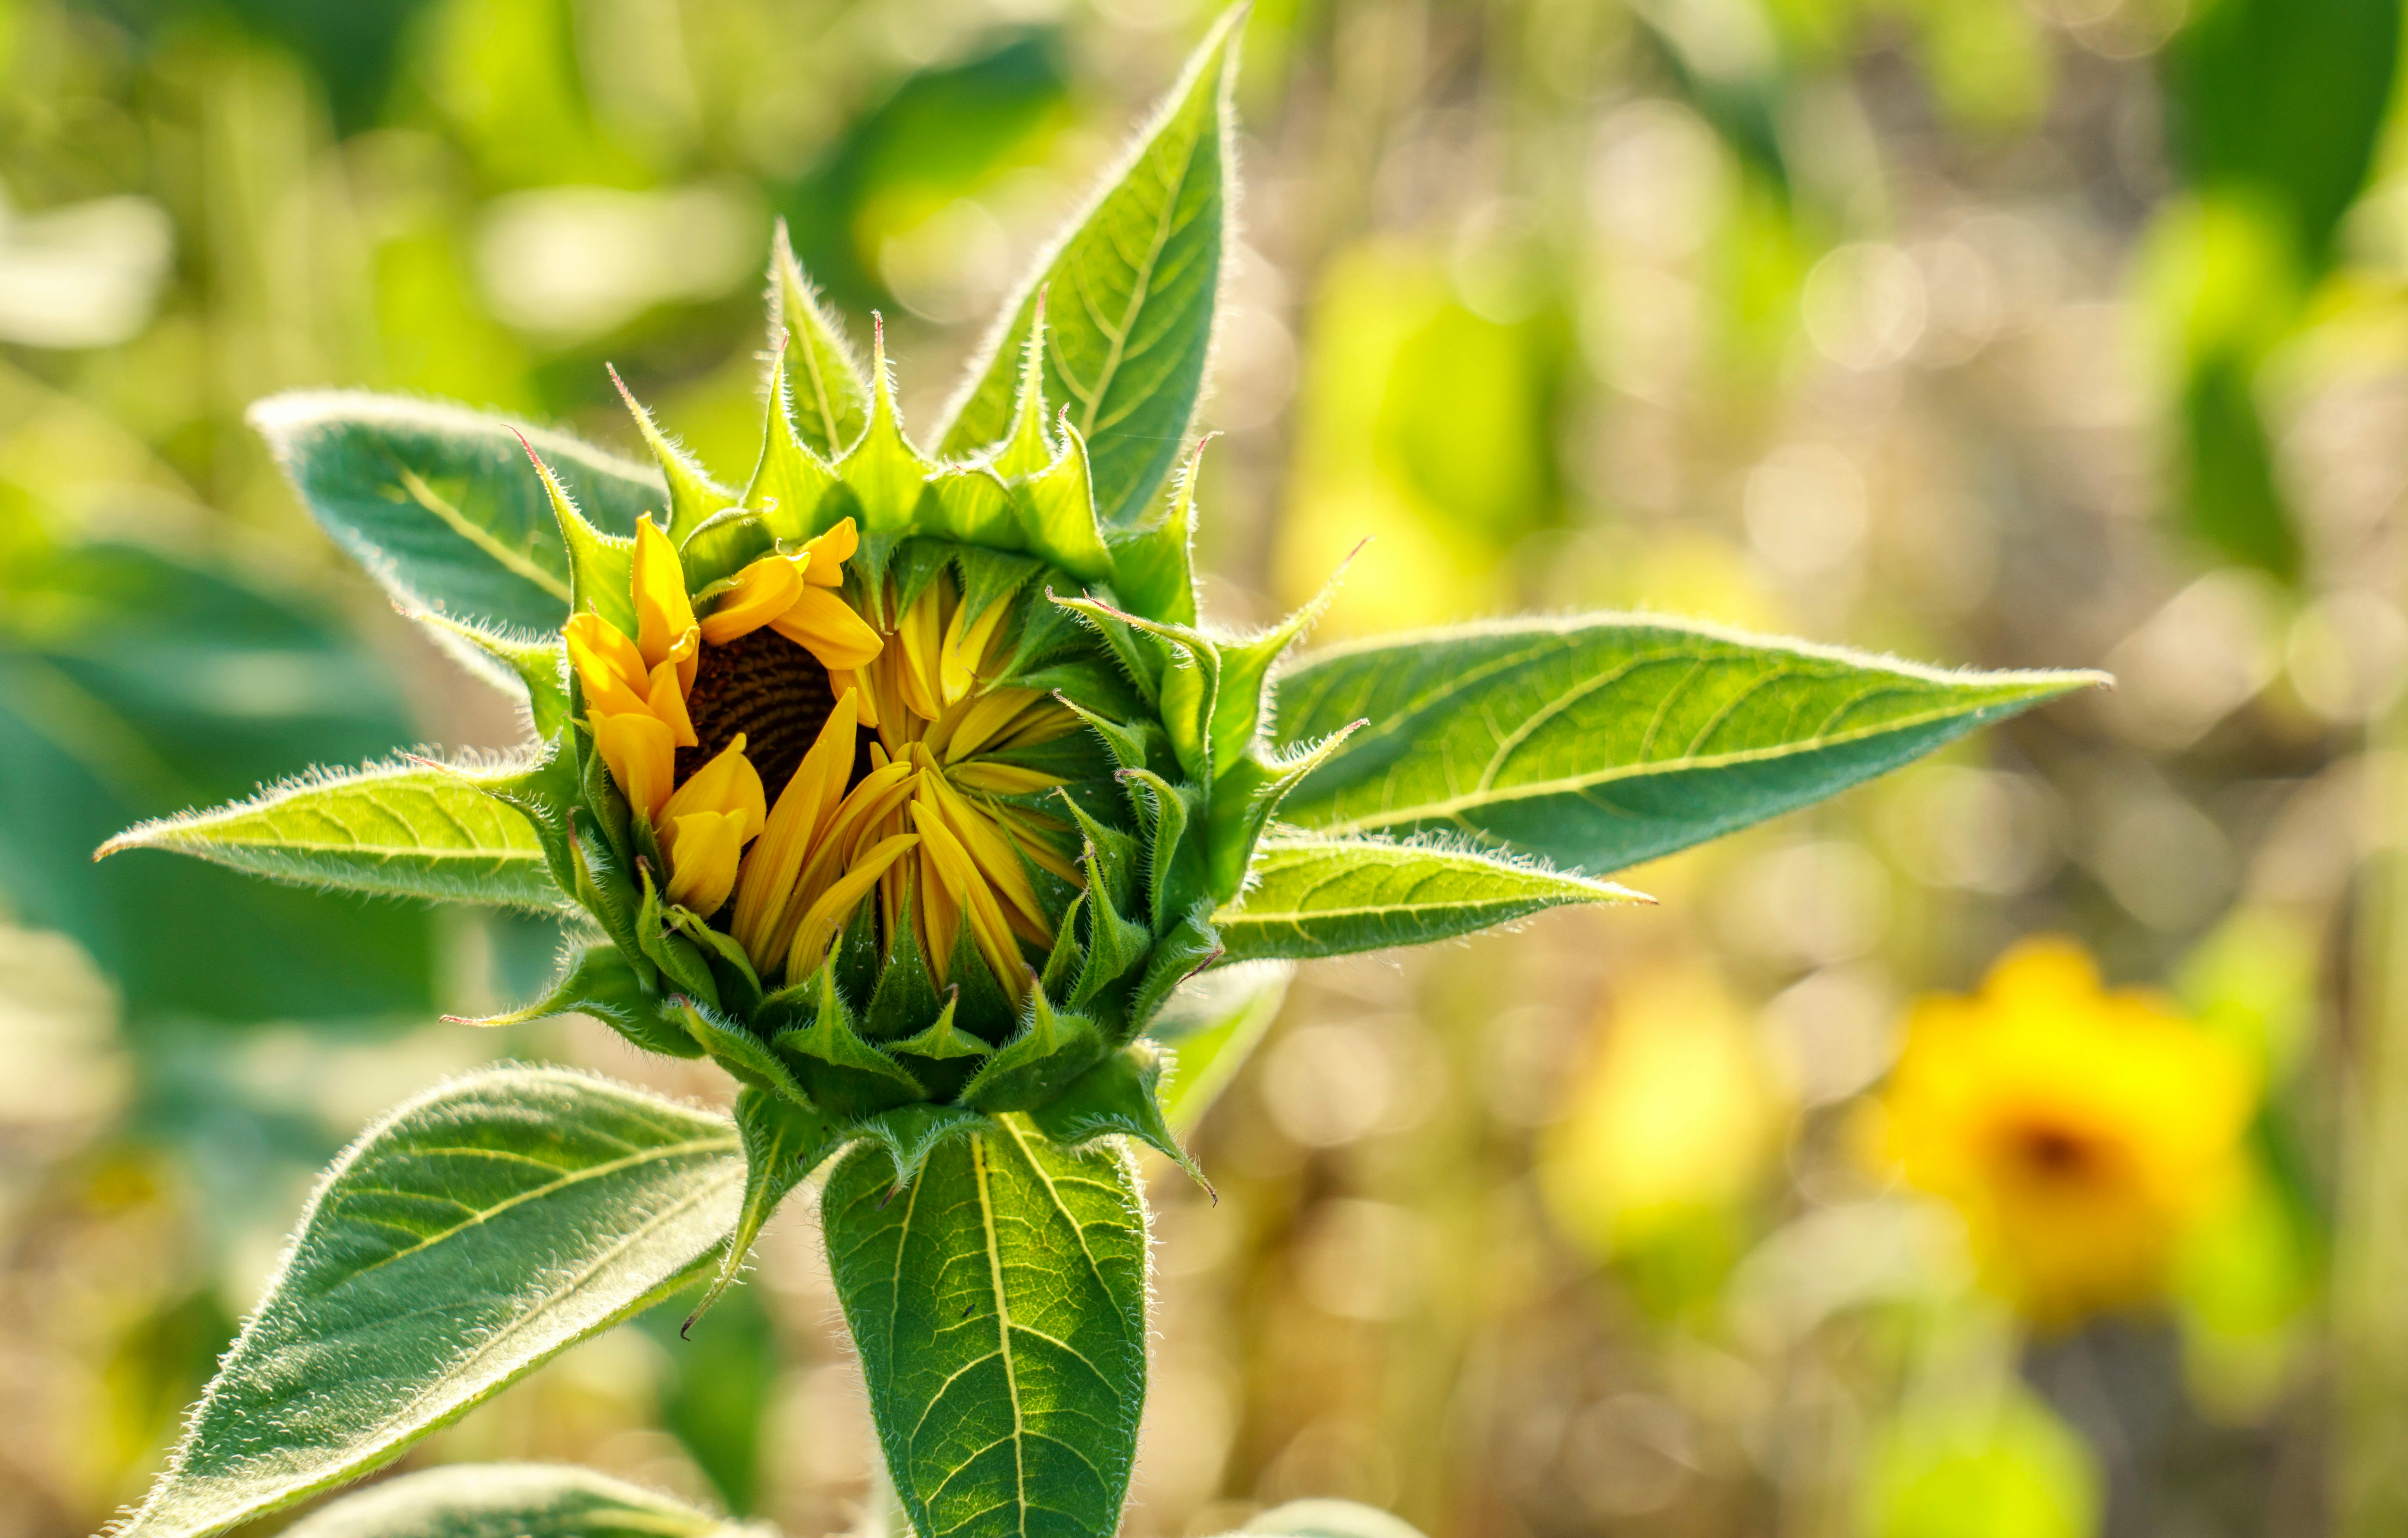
[939,7,1242,527]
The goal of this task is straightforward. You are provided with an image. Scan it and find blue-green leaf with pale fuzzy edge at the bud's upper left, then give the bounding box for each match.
[250,390,667,631]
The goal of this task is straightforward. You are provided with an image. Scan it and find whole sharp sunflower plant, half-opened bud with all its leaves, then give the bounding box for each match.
[89,19,2092,1538]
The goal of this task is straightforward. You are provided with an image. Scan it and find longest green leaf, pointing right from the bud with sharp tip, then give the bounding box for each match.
[1276,616,2105,871]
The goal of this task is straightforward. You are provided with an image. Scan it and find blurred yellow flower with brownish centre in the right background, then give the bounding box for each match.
[1873,939,2256,1326]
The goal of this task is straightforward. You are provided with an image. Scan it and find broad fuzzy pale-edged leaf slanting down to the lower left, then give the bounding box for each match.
[118,1069,744,1538]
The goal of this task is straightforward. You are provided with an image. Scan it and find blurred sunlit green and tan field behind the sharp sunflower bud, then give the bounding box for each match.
[0,0,2408,1538]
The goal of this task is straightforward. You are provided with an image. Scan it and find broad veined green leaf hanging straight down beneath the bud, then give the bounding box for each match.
[821,1119,1146,1538]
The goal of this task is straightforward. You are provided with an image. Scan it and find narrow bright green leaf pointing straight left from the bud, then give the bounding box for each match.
[99,763,573,910]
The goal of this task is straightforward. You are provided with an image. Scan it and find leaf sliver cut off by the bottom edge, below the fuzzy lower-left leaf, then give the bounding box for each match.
[284,1463,754,1538]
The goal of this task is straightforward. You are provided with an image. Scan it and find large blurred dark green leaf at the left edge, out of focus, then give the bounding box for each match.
[0,544,434,1025]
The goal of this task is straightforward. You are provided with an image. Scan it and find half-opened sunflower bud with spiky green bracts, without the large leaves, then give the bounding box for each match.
[522,236,1339,1146]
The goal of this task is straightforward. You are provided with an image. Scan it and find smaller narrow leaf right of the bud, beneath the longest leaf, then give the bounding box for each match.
[1214,838,1645,960]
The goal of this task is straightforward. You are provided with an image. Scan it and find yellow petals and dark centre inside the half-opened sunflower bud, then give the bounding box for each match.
[566,517,1081,994]
